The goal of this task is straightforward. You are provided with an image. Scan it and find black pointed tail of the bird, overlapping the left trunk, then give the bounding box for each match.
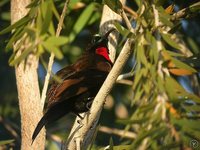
[32,103,68,143]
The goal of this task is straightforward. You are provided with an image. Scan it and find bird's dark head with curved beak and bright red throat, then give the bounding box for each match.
[89,29,115,62]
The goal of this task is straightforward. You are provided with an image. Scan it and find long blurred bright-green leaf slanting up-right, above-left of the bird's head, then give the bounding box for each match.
[69,3,95,43]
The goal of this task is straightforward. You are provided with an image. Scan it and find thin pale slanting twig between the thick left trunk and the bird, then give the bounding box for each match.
[41,0,70,106]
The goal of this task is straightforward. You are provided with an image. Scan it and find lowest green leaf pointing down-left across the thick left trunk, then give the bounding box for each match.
[9,45,34,66]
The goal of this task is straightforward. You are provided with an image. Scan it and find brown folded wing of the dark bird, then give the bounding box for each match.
[47,69,108,107]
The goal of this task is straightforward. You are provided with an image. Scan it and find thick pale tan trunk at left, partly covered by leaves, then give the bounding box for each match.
[11,0,45,150]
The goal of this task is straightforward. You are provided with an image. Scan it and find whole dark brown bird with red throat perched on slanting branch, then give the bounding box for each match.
[32,29,114,142]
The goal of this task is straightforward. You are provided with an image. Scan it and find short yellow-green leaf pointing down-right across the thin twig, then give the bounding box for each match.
[42,41,63,59]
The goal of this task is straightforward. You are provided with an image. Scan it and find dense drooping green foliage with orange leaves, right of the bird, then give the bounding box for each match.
[104,1,200,149]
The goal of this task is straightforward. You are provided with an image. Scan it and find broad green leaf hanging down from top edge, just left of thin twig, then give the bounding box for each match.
[41,0,52,34]
